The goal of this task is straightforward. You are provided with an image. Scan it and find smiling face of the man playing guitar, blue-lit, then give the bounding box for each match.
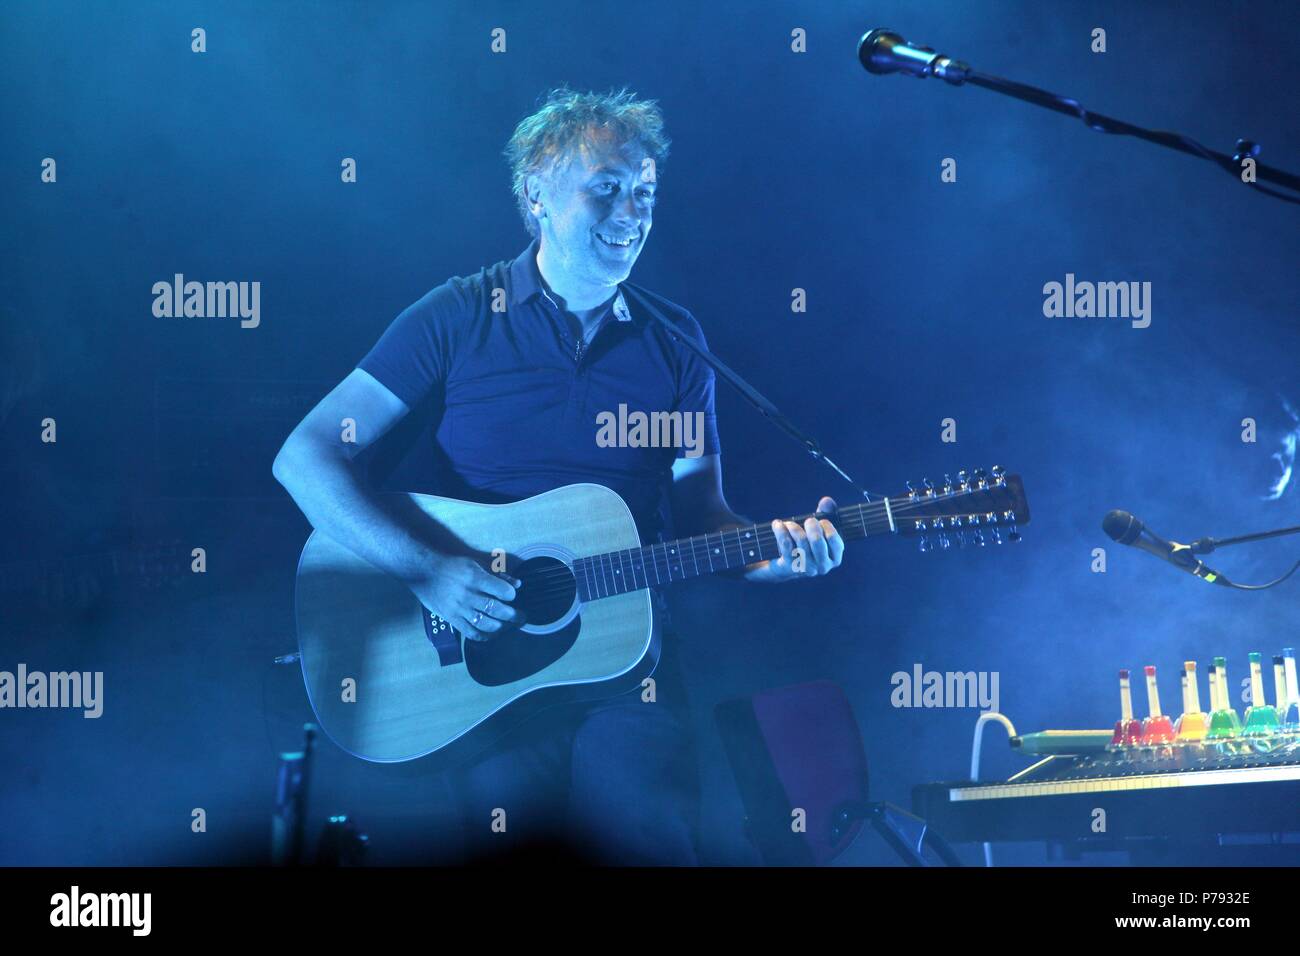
[536,135,658,286]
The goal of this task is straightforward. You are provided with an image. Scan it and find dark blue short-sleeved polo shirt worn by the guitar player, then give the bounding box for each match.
[358,241,720,544]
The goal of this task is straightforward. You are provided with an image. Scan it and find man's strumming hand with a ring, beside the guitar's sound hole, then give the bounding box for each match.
[410,555,525,641]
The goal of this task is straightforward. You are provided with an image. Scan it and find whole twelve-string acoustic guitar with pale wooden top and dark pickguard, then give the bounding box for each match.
[295,467,1030,762]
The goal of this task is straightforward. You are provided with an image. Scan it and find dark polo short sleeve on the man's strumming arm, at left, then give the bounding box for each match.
[356,282,465,408]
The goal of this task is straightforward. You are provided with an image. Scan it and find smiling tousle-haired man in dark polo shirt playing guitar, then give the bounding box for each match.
[274,90,844,864]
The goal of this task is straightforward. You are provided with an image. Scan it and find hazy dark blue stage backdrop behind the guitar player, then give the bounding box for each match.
[0,0,1300,864]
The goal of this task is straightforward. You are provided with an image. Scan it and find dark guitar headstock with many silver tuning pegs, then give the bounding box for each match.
[889,464,1030,551]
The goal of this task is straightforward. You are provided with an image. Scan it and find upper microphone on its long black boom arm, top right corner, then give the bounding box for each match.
[858,30,1300,204]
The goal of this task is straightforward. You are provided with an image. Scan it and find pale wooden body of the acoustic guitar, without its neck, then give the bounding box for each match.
[295,484,659,762]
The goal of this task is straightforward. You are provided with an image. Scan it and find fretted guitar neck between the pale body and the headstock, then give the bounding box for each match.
[573,497,910,601]
